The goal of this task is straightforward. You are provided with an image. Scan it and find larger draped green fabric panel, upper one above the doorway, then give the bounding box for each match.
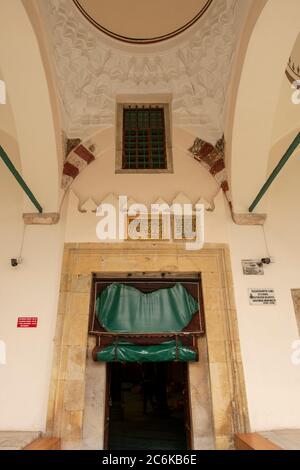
[96,283,199,333]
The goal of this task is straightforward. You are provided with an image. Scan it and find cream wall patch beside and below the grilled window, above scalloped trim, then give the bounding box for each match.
[73,128,218,208]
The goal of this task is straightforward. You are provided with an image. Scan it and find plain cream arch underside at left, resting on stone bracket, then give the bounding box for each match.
[0,0,60,212]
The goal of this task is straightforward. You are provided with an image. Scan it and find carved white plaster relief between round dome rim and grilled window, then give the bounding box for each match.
[39,0,242,139]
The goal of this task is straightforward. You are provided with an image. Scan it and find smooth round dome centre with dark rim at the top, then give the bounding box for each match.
[73,0,213,44]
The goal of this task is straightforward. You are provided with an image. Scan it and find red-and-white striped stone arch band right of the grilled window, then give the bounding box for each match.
[189,136,230,196]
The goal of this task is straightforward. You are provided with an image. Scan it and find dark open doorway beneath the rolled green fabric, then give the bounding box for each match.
[105,362,191,450]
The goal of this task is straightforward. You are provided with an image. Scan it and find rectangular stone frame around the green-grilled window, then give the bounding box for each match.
[115,102,173,174]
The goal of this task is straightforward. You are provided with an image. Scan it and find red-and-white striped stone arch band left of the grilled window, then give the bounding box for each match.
[62,144,95,191]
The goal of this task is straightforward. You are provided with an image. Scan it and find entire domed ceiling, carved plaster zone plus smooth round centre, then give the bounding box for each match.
[38,0,252,143]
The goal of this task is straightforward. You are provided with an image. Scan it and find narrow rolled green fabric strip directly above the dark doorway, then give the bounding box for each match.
[95,341,197,362]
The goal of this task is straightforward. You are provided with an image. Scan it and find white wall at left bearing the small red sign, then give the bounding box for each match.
[0,76,63,430]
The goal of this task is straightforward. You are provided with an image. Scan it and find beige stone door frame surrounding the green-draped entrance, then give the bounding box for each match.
[47,241,249,449]
